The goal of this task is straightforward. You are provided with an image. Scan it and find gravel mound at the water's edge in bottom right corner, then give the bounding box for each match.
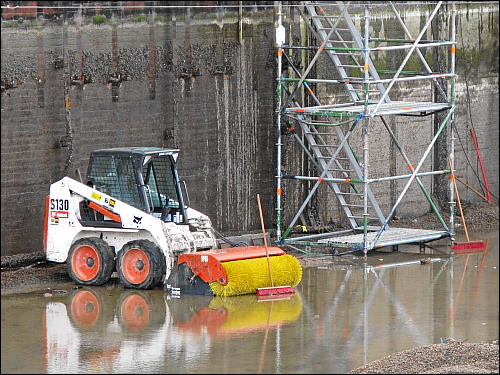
[349,340,499,374]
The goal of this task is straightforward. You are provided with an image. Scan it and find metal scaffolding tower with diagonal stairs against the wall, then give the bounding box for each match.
[276,1,456,255]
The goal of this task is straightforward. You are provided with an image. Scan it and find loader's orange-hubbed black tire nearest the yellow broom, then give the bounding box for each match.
[116,240,166,289]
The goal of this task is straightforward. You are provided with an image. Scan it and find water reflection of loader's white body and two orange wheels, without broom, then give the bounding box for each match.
[44,288,168,373]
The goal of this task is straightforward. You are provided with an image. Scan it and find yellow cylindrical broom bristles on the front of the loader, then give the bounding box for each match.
[209,254,302,296]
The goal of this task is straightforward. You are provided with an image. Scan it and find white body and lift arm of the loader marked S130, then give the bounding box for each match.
[45,177,217,279]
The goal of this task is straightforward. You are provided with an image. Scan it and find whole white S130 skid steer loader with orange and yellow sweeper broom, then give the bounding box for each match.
[44,147,302,295]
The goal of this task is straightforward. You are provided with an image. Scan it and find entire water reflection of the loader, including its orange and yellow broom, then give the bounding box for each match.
[44,287,302,373]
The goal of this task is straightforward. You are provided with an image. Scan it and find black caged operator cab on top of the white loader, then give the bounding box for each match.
[87,147,187,224]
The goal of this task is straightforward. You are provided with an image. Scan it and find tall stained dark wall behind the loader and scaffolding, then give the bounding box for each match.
[1,2,498,255]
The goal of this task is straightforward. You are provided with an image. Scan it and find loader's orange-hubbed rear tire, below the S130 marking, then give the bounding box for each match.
[66,237,115,285]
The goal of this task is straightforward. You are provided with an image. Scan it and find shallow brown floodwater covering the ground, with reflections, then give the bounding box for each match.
[1,230,499,373]
